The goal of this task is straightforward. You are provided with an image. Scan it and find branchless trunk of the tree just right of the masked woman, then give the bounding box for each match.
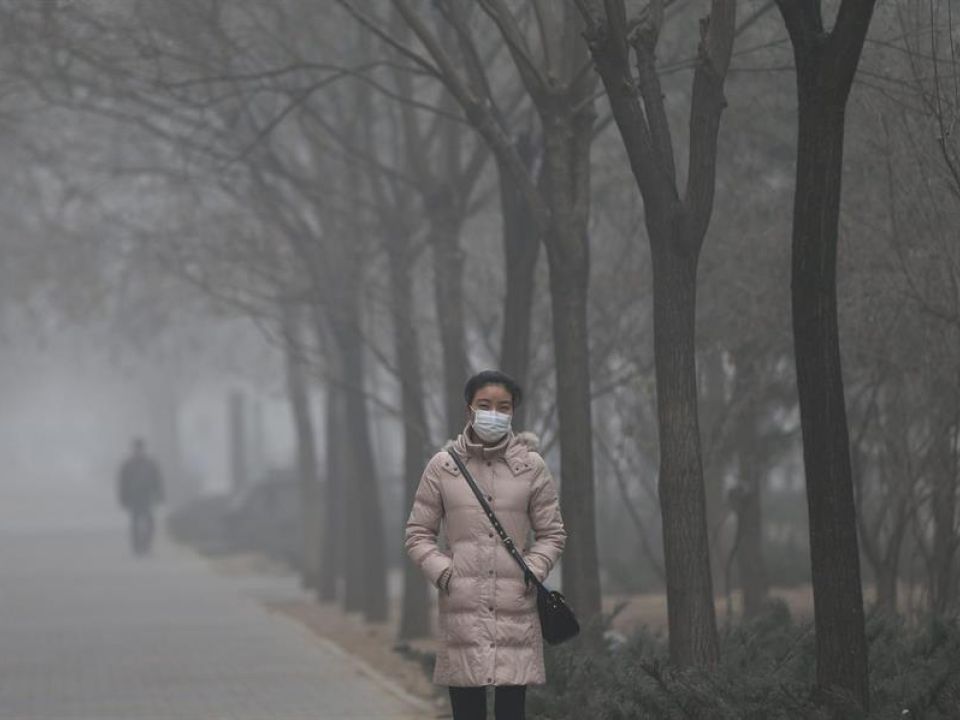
[544,112,601,621]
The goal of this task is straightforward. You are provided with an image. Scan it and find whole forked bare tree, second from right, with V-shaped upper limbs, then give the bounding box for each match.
[577,0,736,667]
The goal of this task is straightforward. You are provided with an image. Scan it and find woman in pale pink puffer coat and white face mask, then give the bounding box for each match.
[406,370,566,720]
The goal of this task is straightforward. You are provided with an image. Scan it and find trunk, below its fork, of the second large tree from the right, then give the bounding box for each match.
[647,239,719,667]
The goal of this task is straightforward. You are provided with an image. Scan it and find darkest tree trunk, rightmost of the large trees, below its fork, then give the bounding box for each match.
[792,80,869,708]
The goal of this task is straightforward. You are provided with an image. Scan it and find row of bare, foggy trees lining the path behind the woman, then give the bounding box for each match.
[3,0,960,706]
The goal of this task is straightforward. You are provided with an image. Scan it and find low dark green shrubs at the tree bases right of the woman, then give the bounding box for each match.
[529,602,960,720]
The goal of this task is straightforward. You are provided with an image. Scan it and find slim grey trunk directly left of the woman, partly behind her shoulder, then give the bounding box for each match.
[387,236,430,640]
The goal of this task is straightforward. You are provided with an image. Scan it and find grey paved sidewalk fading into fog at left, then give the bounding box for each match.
[0,528,431,720]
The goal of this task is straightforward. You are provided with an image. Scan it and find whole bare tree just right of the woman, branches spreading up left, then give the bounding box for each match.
[338,0,600,618]
